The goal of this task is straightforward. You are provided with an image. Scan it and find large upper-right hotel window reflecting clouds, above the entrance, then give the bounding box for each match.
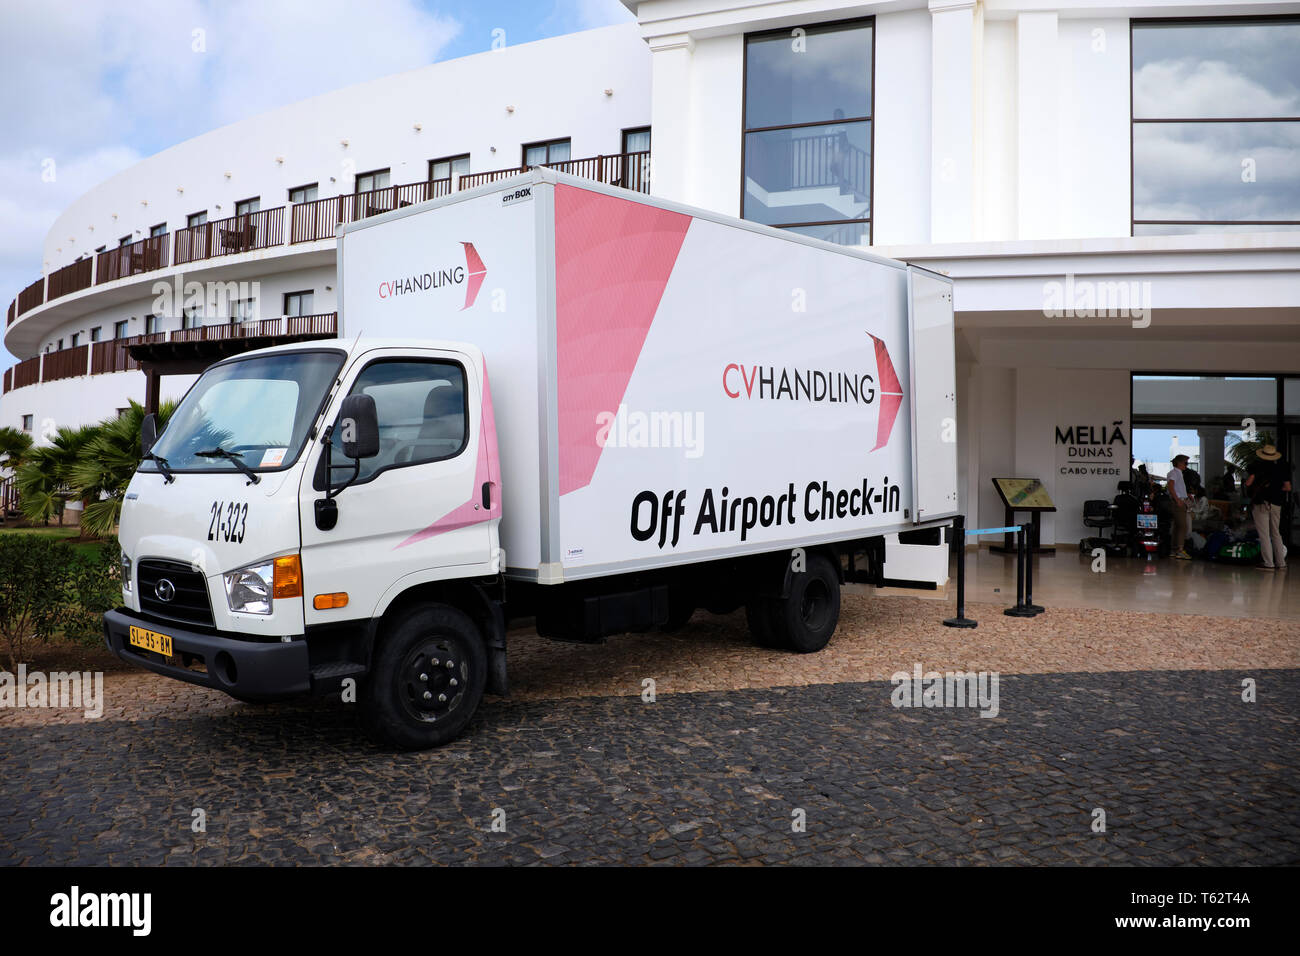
[1131,17,1300,235]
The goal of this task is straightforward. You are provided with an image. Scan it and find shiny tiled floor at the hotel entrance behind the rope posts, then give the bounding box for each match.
[946,548,1300,620]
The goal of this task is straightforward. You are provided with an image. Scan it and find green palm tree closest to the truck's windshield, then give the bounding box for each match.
[68,401,176,537]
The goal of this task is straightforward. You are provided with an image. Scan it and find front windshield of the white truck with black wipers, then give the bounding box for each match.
[140,350,343,472]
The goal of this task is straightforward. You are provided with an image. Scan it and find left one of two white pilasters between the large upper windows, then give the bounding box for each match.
[930,0,975,242]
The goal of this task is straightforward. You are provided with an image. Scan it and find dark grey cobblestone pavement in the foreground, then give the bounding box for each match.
[0,670,1300,865]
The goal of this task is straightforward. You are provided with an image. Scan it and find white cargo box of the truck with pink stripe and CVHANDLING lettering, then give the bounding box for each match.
[339,170,957,583]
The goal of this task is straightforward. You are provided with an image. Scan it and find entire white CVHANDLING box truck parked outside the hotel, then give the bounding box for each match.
[104,170,957,748]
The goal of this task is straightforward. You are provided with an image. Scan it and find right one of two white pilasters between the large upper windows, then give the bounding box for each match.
[1015,12,1061,239]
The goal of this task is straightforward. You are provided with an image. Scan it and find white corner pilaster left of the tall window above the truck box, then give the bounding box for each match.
[647,34,696,203]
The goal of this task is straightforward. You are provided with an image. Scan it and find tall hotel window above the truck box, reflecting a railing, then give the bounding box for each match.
[741,20,875,246]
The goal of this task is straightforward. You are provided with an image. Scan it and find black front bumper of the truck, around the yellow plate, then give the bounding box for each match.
[104,607,311,700]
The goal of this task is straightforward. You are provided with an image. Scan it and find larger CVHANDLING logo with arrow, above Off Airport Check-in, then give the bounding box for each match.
[723,332,902,451]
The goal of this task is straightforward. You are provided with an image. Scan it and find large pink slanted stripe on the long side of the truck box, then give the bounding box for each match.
[555,183,690,494]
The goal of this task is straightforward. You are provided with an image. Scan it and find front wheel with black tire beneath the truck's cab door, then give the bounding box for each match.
[360,604,488,750]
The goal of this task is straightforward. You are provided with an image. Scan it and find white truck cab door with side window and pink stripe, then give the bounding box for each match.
[299,350,501,624]
